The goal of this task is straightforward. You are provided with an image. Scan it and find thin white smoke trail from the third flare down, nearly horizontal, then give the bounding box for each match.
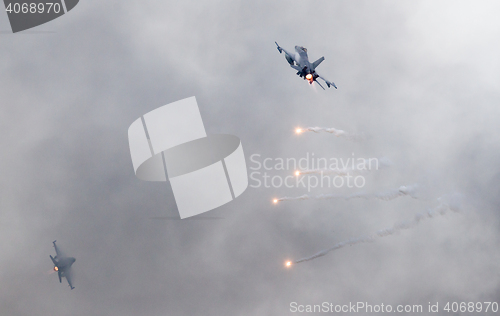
[275,184,418,202]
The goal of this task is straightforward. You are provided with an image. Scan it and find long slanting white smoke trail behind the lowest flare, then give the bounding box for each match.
[294,195,460,263]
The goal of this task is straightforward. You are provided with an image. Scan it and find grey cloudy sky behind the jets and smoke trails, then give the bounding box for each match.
[0,0,500,316]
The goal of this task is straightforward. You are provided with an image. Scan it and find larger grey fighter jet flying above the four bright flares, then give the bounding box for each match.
[274,42,337,90]
